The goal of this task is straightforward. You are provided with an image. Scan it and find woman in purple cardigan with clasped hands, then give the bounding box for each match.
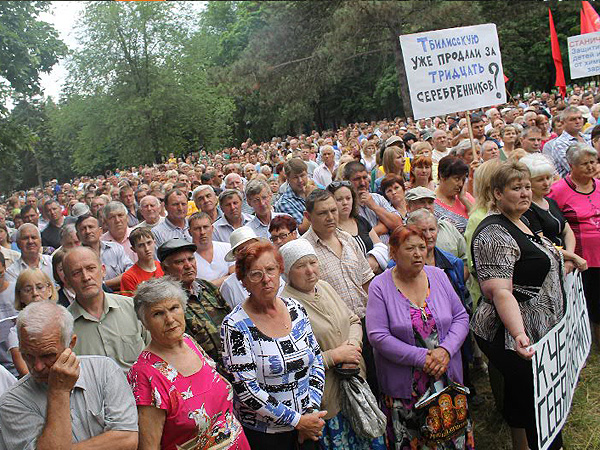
[366,225,474,450]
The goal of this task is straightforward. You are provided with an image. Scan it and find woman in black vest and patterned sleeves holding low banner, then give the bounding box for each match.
[471,161,565,450]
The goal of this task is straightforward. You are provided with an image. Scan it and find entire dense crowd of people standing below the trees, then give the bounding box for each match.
[0,86,600,450]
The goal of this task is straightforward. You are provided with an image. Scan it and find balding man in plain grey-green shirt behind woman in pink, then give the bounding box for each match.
[63,247,150,373]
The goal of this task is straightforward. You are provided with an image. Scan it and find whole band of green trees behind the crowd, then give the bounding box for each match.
[0,0,596,192]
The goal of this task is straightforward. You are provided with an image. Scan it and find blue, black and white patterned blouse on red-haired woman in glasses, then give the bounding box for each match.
[221,298,325,433]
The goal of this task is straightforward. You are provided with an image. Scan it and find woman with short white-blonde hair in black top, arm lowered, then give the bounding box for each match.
[520,153,587,273]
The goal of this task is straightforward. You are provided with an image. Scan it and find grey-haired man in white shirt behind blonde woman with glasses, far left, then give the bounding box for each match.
[6,223,54,282]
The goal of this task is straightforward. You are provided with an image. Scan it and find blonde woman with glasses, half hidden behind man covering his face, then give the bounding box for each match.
[7,269,58,376]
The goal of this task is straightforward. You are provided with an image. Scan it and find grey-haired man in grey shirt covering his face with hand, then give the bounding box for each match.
[0,301,138,450]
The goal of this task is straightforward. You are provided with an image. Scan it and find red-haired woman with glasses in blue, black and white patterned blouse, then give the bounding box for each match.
[221,241,327,450]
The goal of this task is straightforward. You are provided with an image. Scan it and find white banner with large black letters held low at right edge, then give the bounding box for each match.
[532,273,592,450]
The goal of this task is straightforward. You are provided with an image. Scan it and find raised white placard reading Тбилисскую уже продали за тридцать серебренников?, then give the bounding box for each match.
[400,24,506,119]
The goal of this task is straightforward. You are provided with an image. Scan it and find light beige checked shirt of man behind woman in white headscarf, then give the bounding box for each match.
[302,226,375,319]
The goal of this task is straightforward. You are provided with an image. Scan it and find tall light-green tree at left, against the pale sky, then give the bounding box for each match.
[53,2,234,173]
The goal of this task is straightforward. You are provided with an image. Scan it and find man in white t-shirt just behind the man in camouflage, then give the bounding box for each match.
[188,212,235,287]
